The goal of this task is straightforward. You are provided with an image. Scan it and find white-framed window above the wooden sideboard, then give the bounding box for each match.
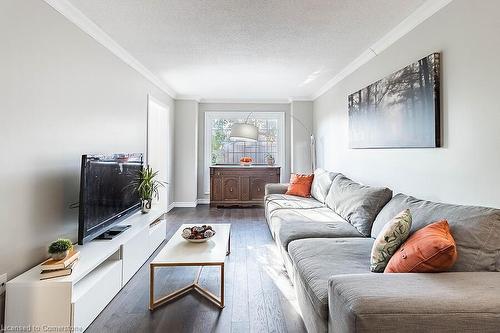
[205,112,285,193]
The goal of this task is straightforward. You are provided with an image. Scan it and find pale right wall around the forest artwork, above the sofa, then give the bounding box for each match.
[314,0,500,208]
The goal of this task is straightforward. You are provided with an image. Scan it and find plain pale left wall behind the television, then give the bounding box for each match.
[0,0,173,278]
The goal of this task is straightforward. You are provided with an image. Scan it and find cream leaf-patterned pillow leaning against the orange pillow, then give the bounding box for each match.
[370,209,411,273]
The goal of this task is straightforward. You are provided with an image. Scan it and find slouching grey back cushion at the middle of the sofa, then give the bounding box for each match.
[326,175,392,237]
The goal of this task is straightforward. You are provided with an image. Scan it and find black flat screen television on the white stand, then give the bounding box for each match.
[78,154,143,244]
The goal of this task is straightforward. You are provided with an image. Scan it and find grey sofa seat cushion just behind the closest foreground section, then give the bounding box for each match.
[288,238,373,320]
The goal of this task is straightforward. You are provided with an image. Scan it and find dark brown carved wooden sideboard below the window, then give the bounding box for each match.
[210,165,280,207]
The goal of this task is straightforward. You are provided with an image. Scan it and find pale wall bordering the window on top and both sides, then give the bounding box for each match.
[198,103,290,200]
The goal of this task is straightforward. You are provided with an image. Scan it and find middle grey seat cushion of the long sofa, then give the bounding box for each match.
[269,207,363,250]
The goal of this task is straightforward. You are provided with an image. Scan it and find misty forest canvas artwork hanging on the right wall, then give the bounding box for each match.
[348,53,441,148]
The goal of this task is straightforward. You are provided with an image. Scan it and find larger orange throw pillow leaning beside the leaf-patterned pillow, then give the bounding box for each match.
[384,220,457,273]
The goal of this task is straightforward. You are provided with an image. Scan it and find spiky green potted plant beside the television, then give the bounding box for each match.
[133,165,166,214]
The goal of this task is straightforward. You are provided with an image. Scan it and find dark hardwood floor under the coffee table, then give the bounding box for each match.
[86,205,305,333]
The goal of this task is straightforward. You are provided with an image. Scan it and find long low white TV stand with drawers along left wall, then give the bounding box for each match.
[5,207,166,332]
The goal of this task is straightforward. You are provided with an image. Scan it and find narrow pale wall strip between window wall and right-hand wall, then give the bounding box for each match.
[290,101,314,173]
